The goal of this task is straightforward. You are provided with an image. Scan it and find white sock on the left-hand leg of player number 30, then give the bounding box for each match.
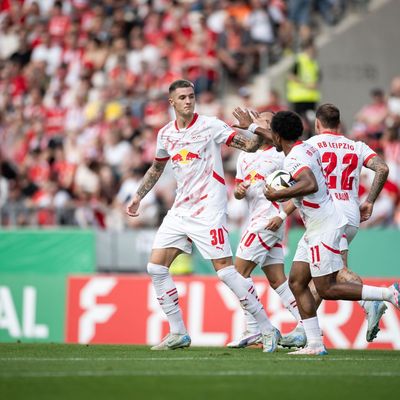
[147,263,186,335]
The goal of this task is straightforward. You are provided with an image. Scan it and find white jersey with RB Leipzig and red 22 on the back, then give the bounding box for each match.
[307,132,376,227]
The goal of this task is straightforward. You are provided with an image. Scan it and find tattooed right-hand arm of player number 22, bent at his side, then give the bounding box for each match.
[360,156,389,222]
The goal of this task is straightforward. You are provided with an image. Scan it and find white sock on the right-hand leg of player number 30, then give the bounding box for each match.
[217,265,272,333]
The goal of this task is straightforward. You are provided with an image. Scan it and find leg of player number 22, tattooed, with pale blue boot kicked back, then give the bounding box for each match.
[337,225,387,342]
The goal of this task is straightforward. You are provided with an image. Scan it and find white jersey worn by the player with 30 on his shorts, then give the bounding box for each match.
[156,114,236,218]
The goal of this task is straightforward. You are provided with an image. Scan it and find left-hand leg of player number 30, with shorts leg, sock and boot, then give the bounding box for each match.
[147,215,191,350]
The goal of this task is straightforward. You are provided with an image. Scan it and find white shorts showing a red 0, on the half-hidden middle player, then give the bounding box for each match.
[236,229,284,267]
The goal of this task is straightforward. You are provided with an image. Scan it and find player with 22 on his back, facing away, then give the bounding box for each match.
[307,104,389,342]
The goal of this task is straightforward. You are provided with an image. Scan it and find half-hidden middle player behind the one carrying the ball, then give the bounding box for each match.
[227,111,306,348]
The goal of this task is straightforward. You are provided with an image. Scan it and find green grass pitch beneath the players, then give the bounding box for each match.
[0,344,400,400]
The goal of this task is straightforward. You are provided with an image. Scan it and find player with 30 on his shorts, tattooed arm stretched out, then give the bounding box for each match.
[126,80,280,352]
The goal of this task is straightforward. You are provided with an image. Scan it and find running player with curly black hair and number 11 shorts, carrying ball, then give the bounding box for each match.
[264,111,400,355]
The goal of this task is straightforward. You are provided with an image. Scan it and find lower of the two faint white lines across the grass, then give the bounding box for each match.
[0,370,400,379]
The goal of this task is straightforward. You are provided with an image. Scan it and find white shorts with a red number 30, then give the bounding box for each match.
[153,210,232,260]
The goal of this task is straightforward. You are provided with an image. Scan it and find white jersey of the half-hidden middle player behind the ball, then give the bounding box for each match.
[236,146,284,225]
